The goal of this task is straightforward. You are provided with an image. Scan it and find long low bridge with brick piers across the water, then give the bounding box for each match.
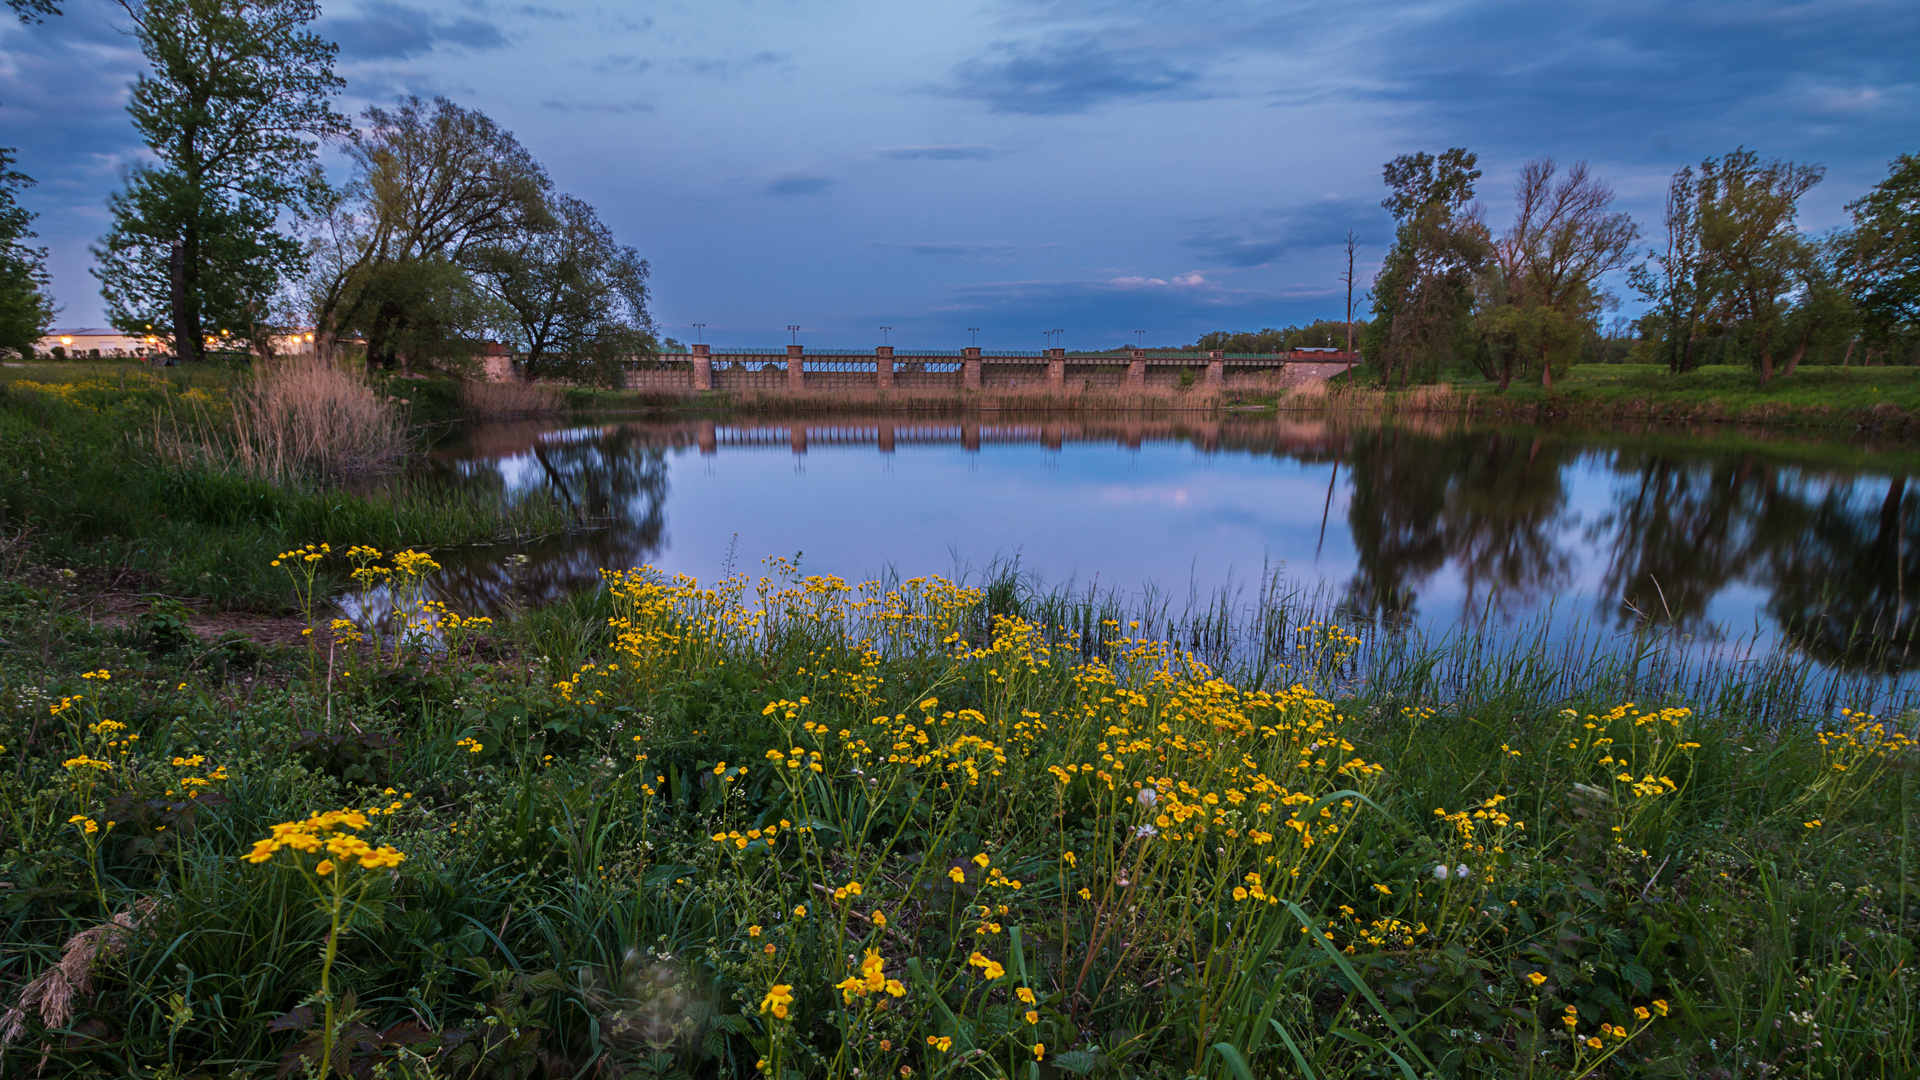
[626,344,1359,394]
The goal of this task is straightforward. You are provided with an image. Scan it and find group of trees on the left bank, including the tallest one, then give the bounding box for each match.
[0,0,657,382]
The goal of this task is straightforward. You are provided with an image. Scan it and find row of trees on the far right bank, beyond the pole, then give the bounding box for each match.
[1363,148,1920,390]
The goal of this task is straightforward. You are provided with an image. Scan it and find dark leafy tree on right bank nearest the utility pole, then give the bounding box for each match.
[1367,146,1488,386]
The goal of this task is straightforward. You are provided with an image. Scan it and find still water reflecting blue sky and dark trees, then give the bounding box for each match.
[412,415,1920,671]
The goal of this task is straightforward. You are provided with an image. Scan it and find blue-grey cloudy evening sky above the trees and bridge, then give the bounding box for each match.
[0,0,1920,348]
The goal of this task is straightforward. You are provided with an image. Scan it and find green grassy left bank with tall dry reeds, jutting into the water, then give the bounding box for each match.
[0,363,570,605]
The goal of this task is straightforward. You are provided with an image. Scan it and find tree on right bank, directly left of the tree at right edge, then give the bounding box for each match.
[1695,148,1824,386]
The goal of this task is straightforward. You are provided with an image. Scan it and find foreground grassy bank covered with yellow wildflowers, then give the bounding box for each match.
[0,555,1920,1080]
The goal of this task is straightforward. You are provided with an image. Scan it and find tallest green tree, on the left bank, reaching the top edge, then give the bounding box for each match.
[94,0,346,359]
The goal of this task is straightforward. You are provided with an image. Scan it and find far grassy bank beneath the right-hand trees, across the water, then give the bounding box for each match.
[1305,363,1920,428]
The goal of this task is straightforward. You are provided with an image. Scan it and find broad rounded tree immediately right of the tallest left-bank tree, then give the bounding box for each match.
[309,98,551,367]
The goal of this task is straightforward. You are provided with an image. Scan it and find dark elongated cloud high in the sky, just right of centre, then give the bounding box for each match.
[947,35,1200,115]
